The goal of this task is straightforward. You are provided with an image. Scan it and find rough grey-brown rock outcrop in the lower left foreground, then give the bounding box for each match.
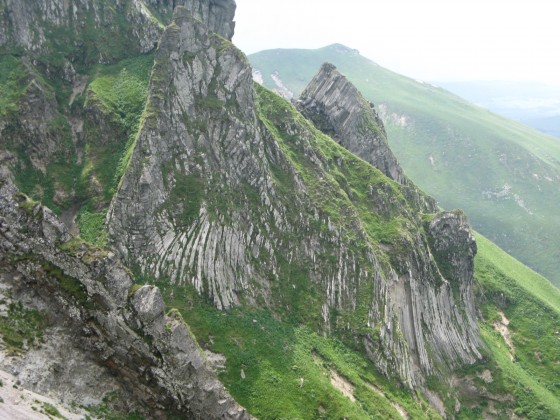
[0,170,249,419]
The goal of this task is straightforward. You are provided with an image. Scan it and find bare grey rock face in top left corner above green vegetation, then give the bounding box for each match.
[0,0,161,60]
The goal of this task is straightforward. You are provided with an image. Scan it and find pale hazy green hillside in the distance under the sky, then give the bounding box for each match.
[249,45,560,284]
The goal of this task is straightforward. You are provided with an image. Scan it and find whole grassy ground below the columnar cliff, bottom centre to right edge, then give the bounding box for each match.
[151,230,560,419]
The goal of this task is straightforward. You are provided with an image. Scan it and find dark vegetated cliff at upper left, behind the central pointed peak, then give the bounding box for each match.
[0,0,235,215]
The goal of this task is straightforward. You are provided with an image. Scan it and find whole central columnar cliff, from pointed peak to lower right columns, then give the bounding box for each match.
[109,2,480,386]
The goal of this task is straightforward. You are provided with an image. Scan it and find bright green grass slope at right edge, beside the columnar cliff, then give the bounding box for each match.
[475,235,560,418]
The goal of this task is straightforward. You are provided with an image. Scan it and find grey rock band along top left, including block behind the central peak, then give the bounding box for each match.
[0,0,236,55]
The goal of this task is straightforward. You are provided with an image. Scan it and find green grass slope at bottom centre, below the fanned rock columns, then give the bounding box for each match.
[155,284,438,419]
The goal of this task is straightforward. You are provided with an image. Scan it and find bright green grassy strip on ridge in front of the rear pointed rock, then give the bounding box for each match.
[256,85,407,248]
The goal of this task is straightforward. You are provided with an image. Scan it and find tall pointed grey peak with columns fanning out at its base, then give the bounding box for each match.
[109,7,273,308]
